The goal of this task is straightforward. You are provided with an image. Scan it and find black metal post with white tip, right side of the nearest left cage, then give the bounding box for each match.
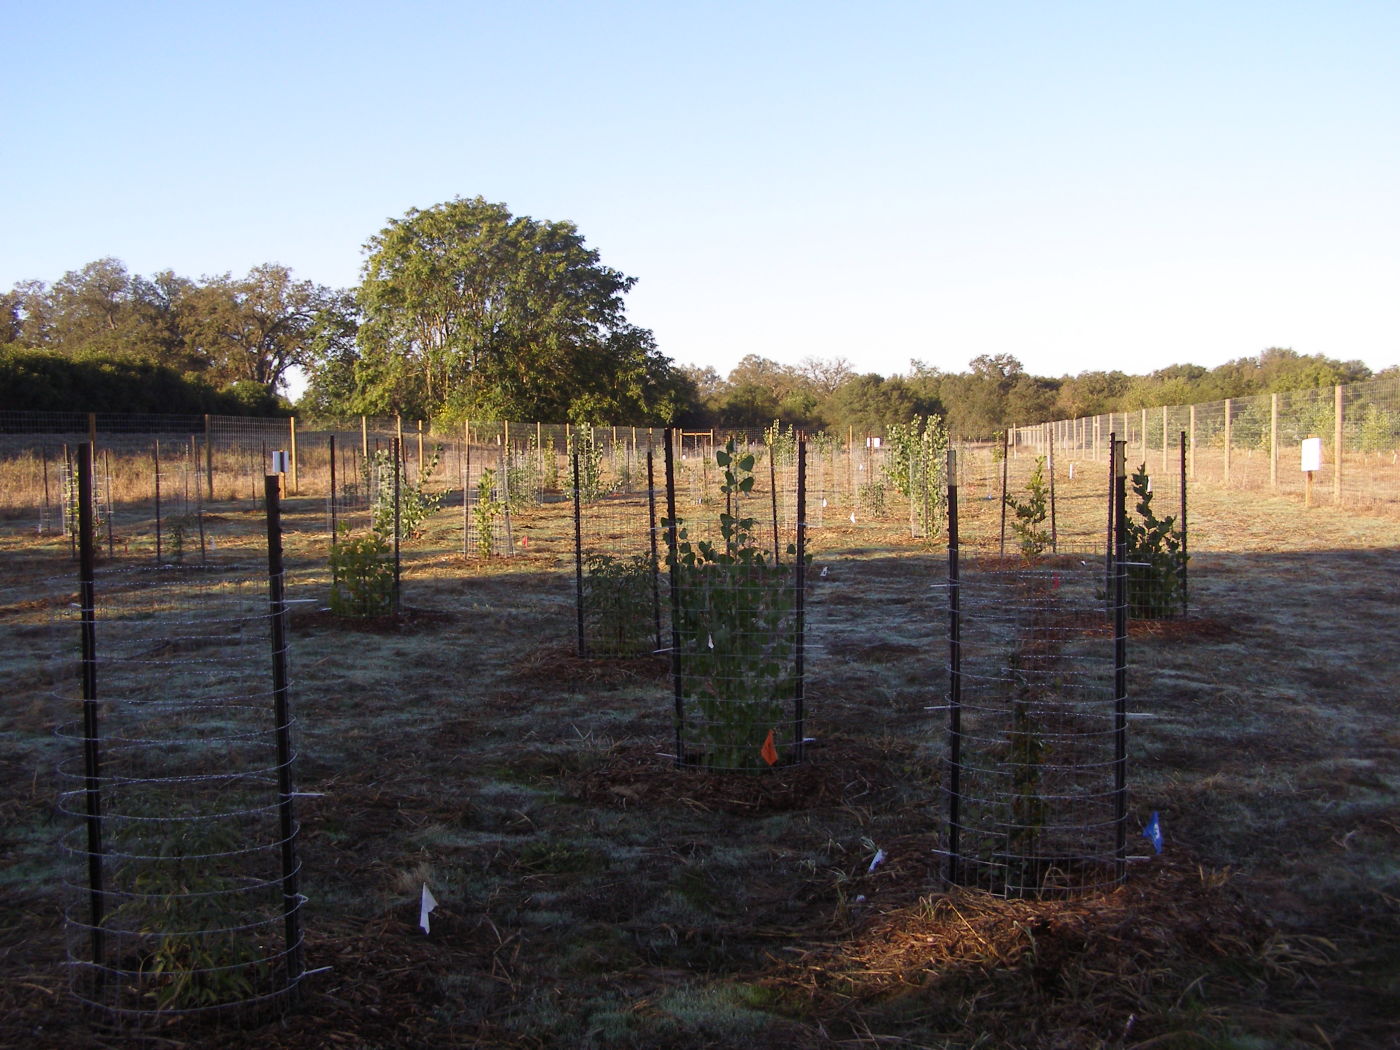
[263,475,302,993]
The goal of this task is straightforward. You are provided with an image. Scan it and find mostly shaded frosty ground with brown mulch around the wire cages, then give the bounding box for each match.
[0,490,1400,1050]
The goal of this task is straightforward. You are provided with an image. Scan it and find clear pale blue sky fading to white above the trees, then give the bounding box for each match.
[0,0,1400,389]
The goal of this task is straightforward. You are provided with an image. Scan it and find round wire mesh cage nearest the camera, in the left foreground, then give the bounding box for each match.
[59,462,304,1030]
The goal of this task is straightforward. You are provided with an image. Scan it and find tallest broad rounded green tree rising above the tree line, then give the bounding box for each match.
[342,197,687,423]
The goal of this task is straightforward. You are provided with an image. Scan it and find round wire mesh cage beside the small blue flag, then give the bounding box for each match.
[942,454,1127,896]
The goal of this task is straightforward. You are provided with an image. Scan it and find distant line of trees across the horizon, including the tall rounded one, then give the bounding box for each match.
[0,197,1396,438]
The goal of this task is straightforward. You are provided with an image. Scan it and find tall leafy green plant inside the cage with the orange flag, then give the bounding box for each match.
[665,440,798,770]
